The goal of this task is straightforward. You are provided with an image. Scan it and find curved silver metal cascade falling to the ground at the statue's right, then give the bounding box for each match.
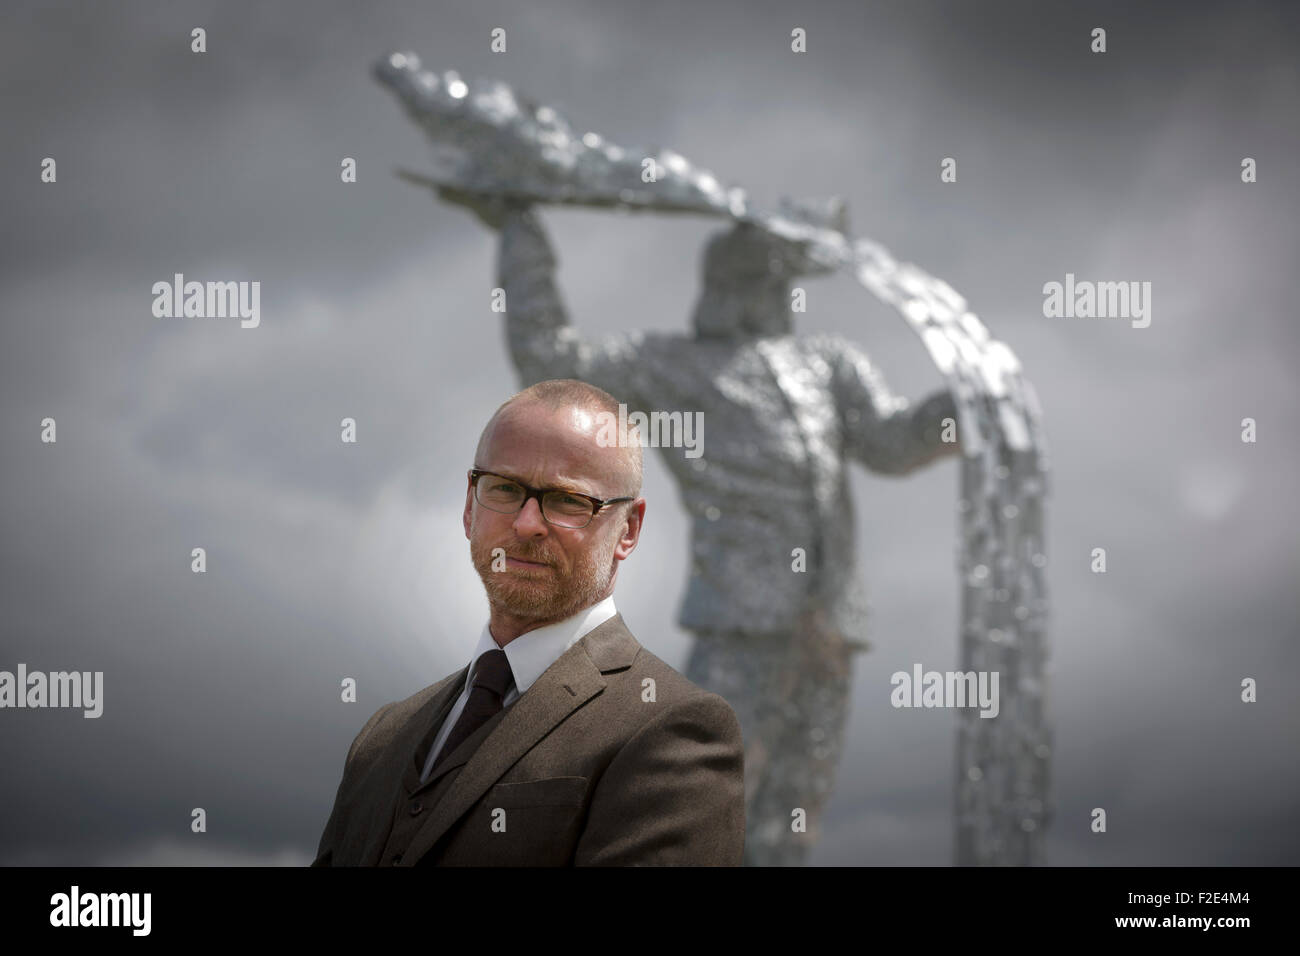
[854,241,1053,865]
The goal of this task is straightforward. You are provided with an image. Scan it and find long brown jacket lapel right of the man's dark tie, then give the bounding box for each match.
[399,614,640,866]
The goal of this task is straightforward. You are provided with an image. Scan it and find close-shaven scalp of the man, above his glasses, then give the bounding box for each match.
[475,378,642,497]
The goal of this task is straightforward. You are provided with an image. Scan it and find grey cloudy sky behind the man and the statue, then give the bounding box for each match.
[0,0,1300,865]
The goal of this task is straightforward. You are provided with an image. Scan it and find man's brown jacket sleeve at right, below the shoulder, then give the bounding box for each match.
[573,695,745,866]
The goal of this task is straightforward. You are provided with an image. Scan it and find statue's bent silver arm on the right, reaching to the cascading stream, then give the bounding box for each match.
[829,343,961,475]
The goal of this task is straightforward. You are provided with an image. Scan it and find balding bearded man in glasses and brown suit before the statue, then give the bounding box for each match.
[312,380,745,866]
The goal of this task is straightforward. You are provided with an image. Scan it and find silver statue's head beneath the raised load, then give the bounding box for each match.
[693,198,848,338]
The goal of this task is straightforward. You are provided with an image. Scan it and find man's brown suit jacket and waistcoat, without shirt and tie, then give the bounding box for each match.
[312,615,745,866]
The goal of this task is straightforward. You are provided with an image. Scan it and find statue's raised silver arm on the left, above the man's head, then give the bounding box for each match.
[497,208,645,397]
